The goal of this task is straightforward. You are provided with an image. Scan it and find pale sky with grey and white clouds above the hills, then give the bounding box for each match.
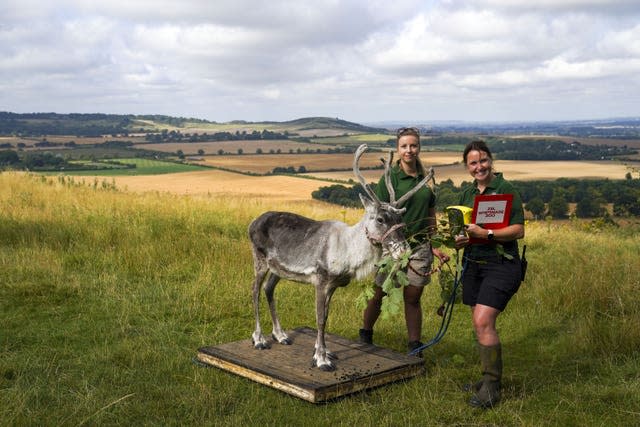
[0,0,640,124]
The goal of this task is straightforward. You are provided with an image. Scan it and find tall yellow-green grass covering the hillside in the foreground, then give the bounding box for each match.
[0,173,640,426]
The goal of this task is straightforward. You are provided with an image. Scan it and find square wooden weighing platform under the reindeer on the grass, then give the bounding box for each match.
[197,327,424,403]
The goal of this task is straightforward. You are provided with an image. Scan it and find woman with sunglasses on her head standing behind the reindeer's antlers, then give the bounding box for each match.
[360,128,449,350]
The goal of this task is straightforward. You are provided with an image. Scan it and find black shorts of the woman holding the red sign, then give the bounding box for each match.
[462,257,522,311]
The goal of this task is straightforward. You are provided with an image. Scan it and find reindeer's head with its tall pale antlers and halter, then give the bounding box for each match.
[353,144,433,259]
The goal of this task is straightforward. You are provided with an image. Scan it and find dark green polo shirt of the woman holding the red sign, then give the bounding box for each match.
[459,173,524,258]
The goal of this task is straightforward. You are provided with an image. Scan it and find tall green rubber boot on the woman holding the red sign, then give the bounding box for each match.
[469,344,502,408]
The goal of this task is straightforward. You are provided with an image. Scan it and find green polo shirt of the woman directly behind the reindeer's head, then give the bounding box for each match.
[376,163,436,247]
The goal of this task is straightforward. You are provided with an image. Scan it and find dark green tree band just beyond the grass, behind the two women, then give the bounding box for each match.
[311,173,640,219]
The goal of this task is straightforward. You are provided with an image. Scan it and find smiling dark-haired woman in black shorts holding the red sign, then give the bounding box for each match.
[456,141,524,408]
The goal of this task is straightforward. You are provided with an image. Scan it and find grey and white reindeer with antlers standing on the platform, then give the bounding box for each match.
[249,144,433,371]
